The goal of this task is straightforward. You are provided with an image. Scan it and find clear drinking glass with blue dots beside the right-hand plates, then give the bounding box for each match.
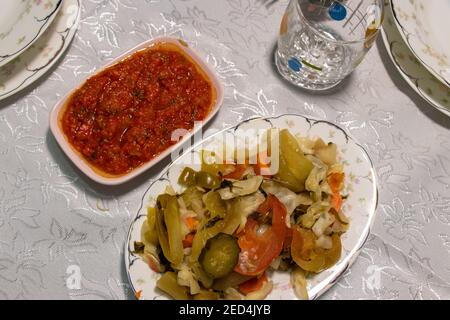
[275,0,384,90]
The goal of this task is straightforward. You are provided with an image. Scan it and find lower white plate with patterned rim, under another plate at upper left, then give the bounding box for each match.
[0,0,81,100]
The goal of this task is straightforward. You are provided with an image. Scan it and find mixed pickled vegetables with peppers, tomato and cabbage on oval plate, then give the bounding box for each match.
[135,130,349,300]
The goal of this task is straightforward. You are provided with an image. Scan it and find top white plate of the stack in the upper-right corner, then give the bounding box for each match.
[391,0,450,87]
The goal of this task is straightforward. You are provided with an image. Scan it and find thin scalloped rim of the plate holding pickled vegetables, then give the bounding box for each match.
[123,113,380,300]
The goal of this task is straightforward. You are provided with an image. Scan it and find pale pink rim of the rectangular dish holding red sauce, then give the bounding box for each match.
[50,37,223,185]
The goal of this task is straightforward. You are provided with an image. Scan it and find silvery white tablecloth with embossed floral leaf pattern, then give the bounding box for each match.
[0,0,450,299]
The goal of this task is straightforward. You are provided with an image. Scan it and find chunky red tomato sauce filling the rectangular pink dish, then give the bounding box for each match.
[60,43,216,176]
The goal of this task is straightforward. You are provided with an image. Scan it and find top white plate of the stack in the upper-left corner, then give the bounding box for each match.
[0,0,62,66]
